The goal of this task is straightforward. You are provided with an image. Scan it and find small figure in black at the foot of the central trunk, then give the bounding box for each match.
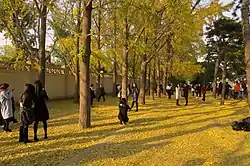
[118,98,130,125]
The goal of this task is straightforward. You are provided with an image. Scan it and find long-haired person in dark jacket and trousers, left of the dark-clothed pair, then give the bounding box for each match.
[19,84,37,143]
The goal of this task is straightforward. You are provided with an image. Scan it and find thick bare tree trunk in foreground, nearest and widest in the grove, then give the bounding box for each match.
[79,0,92,128]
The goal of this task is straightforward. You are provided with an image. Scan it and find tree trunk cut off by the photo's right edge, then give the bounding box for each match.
[241,0,250,108]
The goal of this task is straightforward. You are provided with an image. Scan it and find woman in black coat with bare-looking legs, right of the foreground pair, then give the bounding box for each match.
[34,80,49,141]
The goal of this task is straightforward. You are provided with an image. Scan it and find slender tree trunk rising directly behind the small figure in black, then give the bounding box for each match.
[122,16,129,99]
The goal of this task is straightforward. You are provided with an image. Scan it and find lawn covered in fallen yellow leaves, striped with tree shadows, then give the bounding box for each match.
[0,97,250,166]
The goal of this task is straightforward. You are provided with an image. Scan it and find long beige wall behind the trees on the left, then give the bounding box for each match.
[0,68,139,99]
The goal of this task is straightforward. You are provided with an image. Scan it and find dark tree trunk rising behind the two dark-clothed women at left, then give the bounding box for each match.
[39,0,47,87]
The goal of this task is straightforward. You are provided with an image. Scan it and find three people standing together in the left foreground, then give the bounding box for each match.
[0,80,49,143]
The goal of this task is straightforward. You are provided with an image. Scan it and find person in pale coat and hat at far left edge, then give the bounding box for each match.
[0,83,13,132]
